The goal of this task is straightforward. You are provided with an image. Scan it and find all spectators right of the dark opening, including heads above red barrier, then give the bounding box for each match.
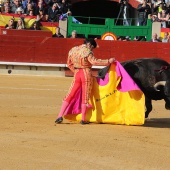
[118,0,170,42]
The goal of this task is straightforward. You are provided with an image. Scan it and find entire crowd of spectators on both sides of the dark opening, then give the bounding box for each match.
[0,0,170,42]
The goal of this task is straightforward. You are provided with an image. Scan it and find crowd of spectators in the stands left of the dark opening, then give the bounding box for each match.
[0,0,71,30]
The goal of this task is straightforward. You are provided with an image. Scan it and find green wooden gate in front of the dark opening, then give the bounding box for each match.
[67,16,152,41]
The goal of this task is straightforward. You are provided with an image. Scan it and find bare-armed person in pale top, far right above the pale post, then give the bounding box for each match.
[158,8,169,28]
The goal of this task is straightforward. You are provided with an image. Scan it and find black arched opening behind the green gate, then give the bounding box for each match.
[71,0,135,25]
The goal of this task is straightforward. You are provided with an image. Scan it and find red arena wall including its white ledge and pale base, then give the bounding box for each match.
[0,29,170,75]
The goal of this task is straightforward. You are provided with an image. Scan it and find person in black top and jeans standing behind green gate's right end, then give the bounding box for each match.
[137,0,151,26]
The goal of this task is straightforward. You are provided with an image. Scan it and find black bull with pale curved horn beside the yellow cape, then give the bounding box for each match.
[98,58,170,118]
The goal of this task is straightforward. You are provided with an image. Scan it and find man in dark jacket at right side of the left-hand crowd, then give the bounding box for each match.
[48,3,61,22]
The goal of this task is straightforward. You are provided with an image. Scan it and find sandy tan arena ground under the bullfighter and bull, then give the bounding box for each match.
[0,75,170,170]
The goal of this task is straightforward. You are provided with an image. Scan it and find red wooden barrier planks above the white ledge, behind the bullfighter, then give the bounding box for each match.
[0,30,170,64]
